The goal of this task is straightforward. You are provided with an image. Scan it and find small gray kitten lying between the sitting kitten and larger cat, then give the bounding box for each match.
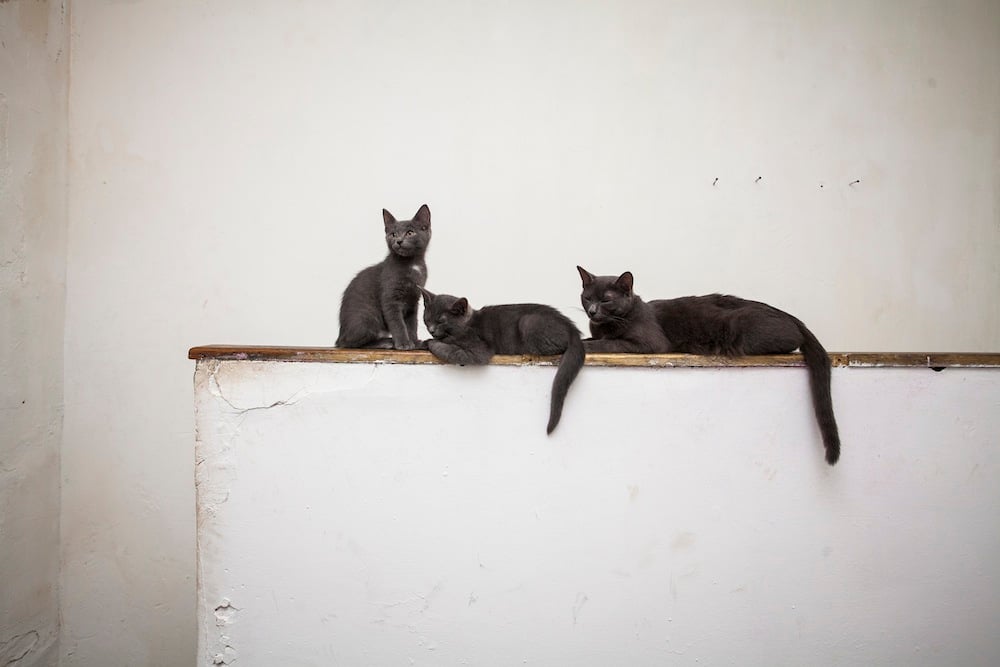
[420,287,584,433]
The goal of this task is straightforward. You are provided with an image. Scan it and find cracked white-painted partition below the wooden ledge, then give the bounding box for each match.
[195,358,1000,667]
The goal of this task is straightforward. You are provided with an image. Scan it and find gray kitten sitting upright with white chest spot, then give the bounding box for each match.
[337,204,431,350]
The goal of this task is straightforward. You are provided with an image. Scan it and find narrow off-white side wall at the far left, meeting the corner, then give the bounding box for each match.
[0,1,69,666]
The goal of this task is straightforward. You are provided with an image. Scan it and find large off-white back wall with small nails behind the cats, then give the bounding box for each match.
[63,0,1000,665]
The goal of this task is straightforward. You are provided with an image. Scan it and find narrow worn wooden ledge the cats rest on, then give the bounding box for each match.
[188,345,1000,369]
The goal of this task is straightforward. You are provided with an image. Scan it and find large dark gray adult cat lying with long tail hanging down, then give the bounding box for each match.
[576,266,840,465]
